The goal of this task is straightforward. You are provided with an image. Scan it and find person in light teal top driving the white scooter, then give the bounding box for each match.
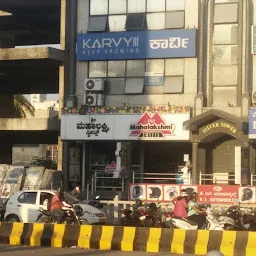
[188,192,206,229]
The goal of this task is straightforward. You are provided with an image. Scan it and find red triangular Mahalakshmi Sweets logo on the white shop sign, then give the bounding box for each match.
[130,112,175,138]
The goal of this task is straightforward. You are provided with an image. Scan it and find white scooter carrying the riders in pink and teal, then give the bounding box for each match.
[170,205,224,230]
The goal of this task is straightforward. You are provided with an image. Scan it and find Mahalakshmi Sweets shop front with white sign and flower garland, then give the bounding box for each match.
[61,106,191,198]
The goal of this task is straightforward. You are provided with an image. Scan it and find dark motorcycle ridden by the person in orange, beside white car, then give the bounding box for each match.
[36,205,88,225]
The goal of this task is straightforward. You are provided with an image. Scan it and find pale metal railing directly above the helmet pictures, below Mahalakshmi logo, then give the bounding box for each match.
[132,171,191,184]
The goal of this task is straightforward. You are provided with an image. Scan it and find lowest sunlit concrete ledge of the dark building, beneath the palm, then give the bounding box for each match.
[0,118,60,131]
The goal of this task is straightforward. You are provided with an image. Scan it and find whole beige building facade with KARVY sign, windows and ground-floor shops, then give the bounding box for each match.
[61,0,256,199]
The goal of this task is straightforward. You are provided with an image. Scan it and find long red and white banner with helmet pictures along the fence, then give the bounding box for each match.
[129,184,256,204]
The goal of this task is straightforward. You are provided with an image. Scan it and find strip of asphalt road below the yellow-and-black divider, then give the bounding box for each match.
[0,245,197,256]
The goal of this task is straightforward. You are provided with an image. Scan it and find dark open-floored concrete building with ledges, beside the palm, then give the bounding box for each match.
[0,0,66,167]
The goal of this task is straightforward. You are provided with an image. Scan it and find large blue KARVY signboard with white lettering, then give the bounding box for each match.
[77,29,196,61]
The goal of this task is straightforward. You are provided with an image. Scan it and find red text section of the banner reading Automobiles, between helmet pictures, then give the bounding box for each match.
[197,185,239,204]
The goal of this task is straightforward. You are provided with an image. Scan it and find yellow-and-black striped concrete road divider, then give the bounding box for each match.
[0,223,256,256]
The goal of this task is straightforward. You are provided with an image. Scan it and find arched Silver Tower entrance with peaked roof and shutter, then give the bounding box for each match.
[184,110,249,185]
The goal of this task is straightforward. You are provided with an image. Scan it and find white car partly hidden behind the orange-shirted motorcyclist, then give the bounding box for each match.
[4,190,106,224]
